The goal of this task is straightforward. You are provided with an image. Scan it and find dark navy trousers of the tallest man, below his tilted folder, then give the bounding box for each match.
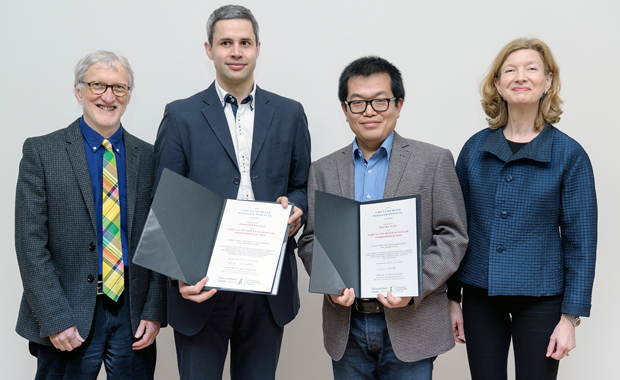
[174,292,284,380]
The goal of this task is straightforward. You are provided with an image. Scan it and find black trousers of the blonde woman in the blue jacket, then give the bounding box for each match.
[463,285,563,380]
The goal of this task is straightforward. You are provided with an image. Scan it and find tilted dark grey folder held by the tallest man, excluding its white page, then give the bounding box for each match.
[133,169,288,294]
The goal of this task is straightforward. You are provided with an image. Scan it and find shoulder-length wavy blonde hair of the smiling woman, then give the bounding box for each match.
[480,38,564,131]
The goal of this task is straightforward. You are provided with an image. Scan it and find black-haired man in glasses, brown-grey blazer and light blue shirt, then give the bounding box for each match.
[299,57,467,380]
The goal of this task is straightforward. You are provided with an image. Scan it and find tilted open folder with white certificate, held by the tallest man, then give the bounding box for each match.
[133,169,293,295]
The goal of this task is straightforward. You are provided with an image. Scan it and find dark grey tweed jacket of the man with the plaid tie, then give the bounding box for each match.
[15,119,166,345]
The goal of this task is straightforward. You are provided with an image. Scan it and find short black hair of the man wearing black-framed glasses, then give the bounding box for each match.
[338,56,405,102]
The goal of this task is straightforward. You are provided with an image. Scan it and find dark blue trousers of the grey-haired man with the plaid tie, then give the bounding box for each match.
[29,294,156,380]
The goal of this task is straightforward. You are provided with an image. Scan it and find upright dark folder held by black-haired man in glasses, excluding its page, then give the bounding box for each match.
[309,190,422,296]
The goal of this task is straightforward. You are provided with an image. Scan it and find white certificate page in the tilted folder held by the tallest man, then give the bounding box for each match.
[206,200,292,293]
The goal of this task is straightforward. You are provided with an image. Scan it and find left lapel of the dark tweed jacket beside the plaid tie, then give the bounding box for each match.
[67,119,97,231]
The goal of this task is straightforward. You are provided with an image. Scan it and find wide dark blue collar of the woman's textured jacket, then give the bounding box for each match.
[478,123,555,162]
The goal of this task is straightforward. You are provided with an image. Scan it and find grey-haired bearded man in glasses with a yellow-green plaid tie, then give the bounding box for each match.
[15,51,166,379]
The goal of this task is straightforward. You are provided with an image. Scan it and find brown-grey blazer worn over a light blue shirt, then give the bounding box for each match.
[299,133,467,362]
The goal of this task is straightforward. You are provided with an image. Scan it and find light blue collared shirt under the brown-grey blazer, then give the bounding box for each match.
[353,131,394,202]
